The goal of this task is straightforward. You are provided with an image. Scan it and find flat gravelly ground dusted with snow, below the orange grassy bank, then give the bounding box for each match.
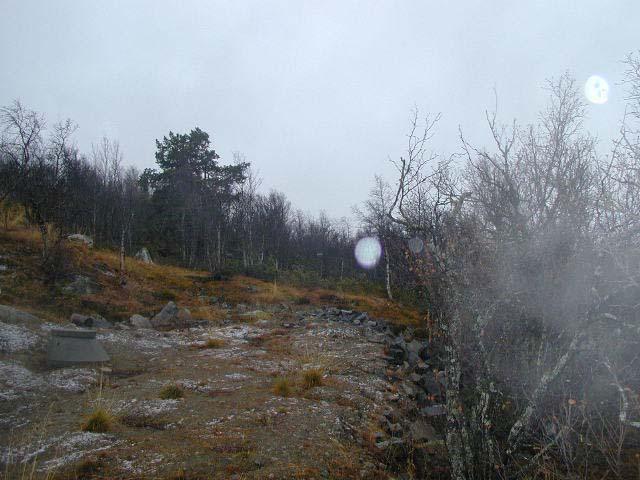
[0,304,447,479]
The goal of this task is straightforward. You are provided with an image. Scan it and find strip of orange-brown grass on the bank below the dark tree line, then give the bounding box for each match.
[0,228,424,325]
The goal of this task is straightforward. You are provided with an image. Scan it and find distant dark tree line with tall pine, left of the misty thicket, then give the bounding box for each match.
[0,108,420,296]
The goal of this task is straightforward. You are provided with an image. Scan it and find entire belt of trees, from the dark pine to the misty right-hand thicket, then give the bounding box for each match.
[0,53,640,480]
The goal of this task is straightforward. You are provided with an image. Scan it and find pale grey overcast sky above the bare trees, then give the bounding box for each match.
[0,0,640,217]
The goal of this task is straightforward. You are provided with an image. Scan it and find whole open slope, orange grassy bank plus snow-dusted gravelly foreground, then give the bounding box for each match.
[0,230,446,479]
